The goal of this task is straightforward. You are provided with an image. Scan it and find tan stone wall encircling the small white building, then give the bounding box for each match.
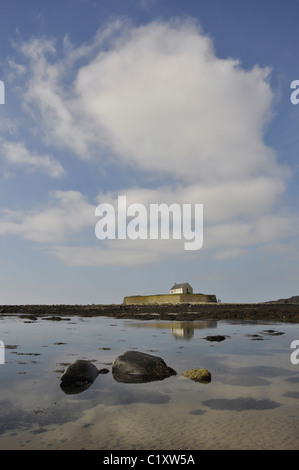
[123,294,217,305]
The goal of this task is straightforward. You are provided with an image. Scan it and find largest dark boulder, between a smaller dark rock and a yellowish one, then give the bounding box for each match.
[112,351,176,383]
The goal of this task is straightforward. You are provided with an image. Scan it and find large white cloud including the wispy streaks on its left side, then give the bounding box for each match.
[15,20,281,183]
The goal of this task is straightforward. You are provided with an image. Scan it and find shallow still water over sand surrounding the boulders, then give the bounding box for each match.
[0,316,299,450]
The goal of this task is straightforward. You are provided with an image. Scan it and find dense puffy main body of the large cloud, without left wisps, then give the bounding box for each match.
[75,22,279,184]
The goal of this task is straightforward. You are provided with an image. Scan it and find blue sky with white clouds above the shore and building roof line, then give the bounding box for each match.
[0,0,299,304]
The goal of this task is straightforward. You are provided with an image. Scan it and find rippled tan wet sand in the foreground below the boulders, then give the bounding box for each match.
[2,398,298,450]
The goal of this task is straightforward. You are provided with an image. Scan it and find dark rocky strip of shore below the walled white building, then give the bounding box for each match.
[0,303,299,323]
